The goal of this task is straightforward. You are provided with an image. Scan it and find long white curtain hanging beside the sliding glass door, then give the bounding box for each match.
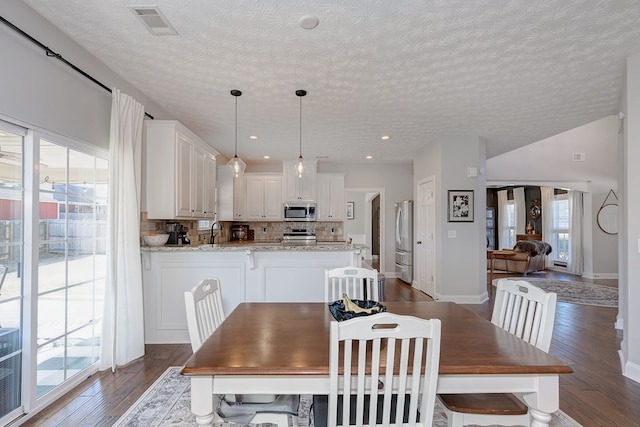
[100,88,144,371]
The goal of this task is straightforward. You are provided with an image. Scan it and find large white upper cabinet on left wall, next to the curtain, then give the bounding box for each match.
[145,120,218,219]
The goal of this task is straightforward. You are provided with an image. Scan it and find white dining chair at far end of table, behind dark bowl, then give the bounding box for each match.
[324,266,380,303]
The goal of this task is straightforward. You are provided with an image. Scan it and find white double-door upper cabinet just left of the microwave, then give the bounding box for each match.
[244,174,282,221]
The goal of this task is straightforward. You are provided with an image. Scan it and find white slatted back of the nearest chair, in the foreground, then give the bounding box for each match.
[327,313,440,427]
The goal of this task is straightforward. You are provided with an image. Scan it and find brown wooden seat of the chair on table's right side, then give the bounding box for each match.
[438,393,529,415]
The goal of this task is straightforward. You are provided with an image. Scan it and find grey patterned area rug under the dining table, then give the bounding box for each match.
[114,366,581,427]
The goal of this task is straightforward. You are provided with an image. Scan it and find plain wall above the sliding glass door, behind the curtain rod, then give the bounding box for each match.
[0,0,171,148]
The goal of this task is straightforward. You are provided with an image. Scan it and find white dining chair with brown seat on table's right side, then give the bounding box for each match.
[438,279,557,427]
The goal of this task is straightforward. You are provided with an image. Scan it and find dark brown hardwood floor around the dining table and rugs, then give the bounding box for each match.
[24,272,640,427]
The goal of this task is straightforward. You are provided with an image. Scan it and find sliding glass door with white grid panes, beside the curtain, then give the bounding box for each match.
[0,120,108,425]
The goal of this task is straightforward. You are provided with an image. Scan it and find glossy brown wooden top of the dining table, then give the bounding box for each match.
[182,301,573,376]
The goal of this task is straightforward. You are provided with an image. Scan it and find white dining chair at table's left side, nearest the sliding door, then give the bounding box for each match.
[184,278,300,427]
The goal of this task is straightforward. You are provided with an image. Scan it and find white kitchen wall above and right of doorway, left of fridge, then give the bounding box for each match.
[318,162,413,277]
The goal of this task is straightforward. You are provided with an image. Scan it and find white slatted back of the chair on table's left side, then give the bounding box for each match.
[184,279,225,353]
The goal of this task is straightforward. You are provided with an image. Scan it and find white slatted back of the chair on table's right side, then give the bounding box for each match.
[491,279,557,352]
